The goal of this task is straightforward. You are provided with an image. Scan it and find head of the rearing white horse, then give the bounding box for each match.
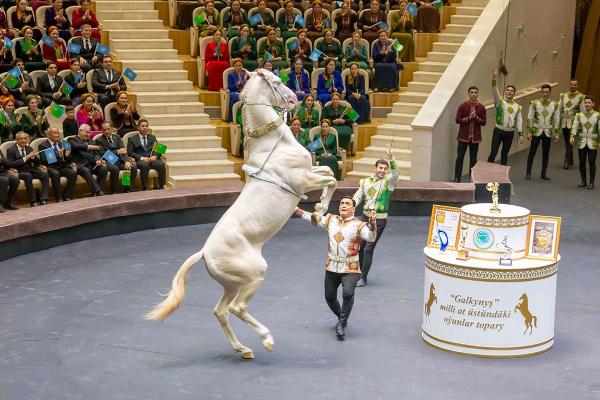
[240,68,298,111]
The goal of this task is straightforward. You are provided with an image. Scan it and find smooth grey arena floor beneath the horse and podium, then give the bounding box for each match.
[0,145,600,400]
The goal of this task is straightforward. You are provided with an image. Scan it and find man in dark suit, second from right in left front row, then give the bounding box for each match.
[96,121,137,194]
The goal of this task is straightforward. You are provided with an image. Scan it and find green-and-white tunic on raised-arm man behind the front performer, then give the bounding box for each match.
[353,160,400,219]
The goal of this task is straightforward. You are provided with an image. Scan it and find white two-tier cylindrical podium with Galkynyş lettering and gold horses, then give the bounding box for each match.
[422,204,558,358]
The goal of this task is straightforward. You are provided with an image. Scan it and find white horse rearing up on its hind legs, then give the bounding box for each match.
[146,69,337,359]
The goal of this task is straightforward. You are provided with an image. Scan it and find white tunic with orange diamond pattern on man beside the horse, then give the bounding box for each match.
[302,211,377,274]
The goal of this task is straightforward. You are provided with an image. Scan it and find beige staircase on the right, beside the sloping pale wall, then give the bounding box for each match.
[347,0,488,180]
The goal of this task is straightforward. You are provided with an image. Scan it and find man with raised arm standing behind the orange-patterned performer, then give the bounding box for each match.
[352,144,400,287]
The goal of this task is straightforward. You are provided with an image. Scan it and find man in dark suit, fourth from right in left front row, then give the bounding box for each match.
[38,128,77,203]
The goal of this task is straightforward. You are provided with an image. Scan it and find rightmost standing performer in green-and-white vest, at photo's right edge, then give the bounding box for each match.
[571,96,600,189]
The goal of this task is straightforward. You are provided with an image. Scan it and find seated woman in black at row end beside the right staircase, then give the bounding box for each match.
[373,29,402,92]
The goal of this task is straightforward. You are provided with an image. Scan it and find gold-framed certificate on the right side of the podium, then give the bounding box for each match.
[526,215,561,261]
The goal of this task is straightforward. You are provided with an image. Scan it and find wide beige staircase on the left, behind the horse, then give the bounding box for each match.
[95,0,240,188]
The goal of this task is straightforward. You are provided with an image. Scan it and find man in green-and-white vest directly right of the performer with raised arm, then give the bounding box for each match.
[525,83,560,181]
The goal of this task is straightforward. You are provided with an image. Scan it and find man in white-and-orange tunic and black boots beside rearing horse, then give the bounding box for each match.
[296,197,377,340]
